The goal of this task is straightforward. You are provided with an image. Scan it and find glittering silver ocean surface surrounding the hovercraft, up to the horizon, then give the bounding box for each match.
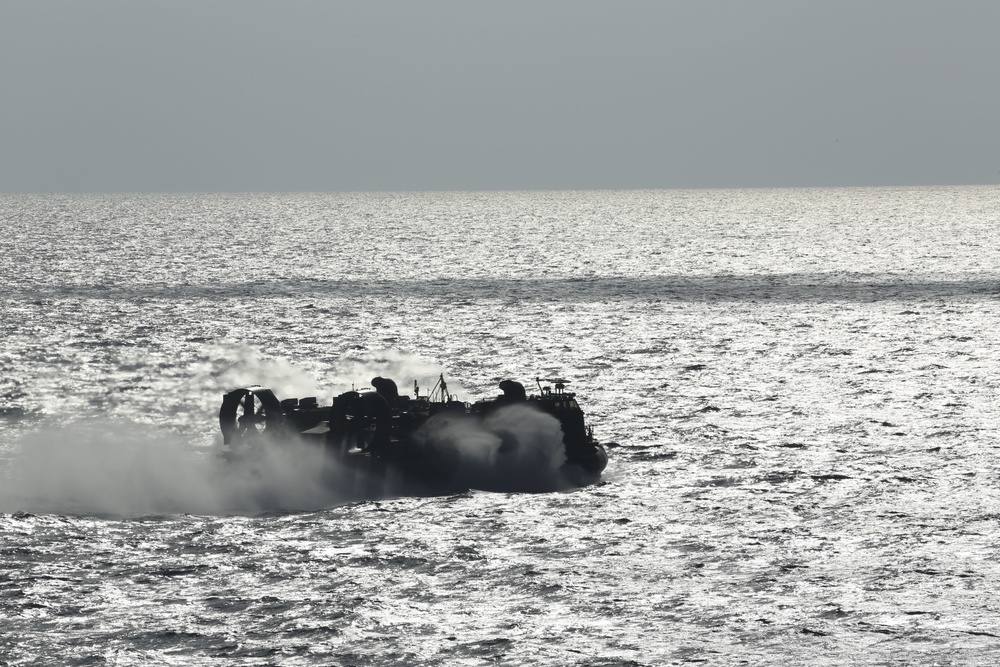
[0,186,1000,667]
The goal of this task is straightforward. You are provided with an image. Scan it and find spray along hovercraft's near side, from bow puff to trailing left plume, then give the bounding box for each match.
[0,408,570,517]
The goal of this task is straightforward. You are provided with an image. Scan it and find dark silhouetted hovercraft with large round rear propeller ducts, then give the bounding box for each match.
[219,375,608,491]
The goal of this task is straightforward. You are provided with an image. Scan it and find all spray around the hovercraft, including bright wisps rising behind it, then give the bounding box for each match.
[0,343,580,516]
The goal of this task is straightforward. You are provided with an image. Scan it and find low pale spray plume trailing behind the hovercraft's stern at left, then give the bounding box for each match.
[0,421,349,516]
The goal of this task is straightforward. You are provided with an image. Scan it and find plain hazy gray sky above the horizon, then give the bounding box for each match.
[0,0,1000,192]
